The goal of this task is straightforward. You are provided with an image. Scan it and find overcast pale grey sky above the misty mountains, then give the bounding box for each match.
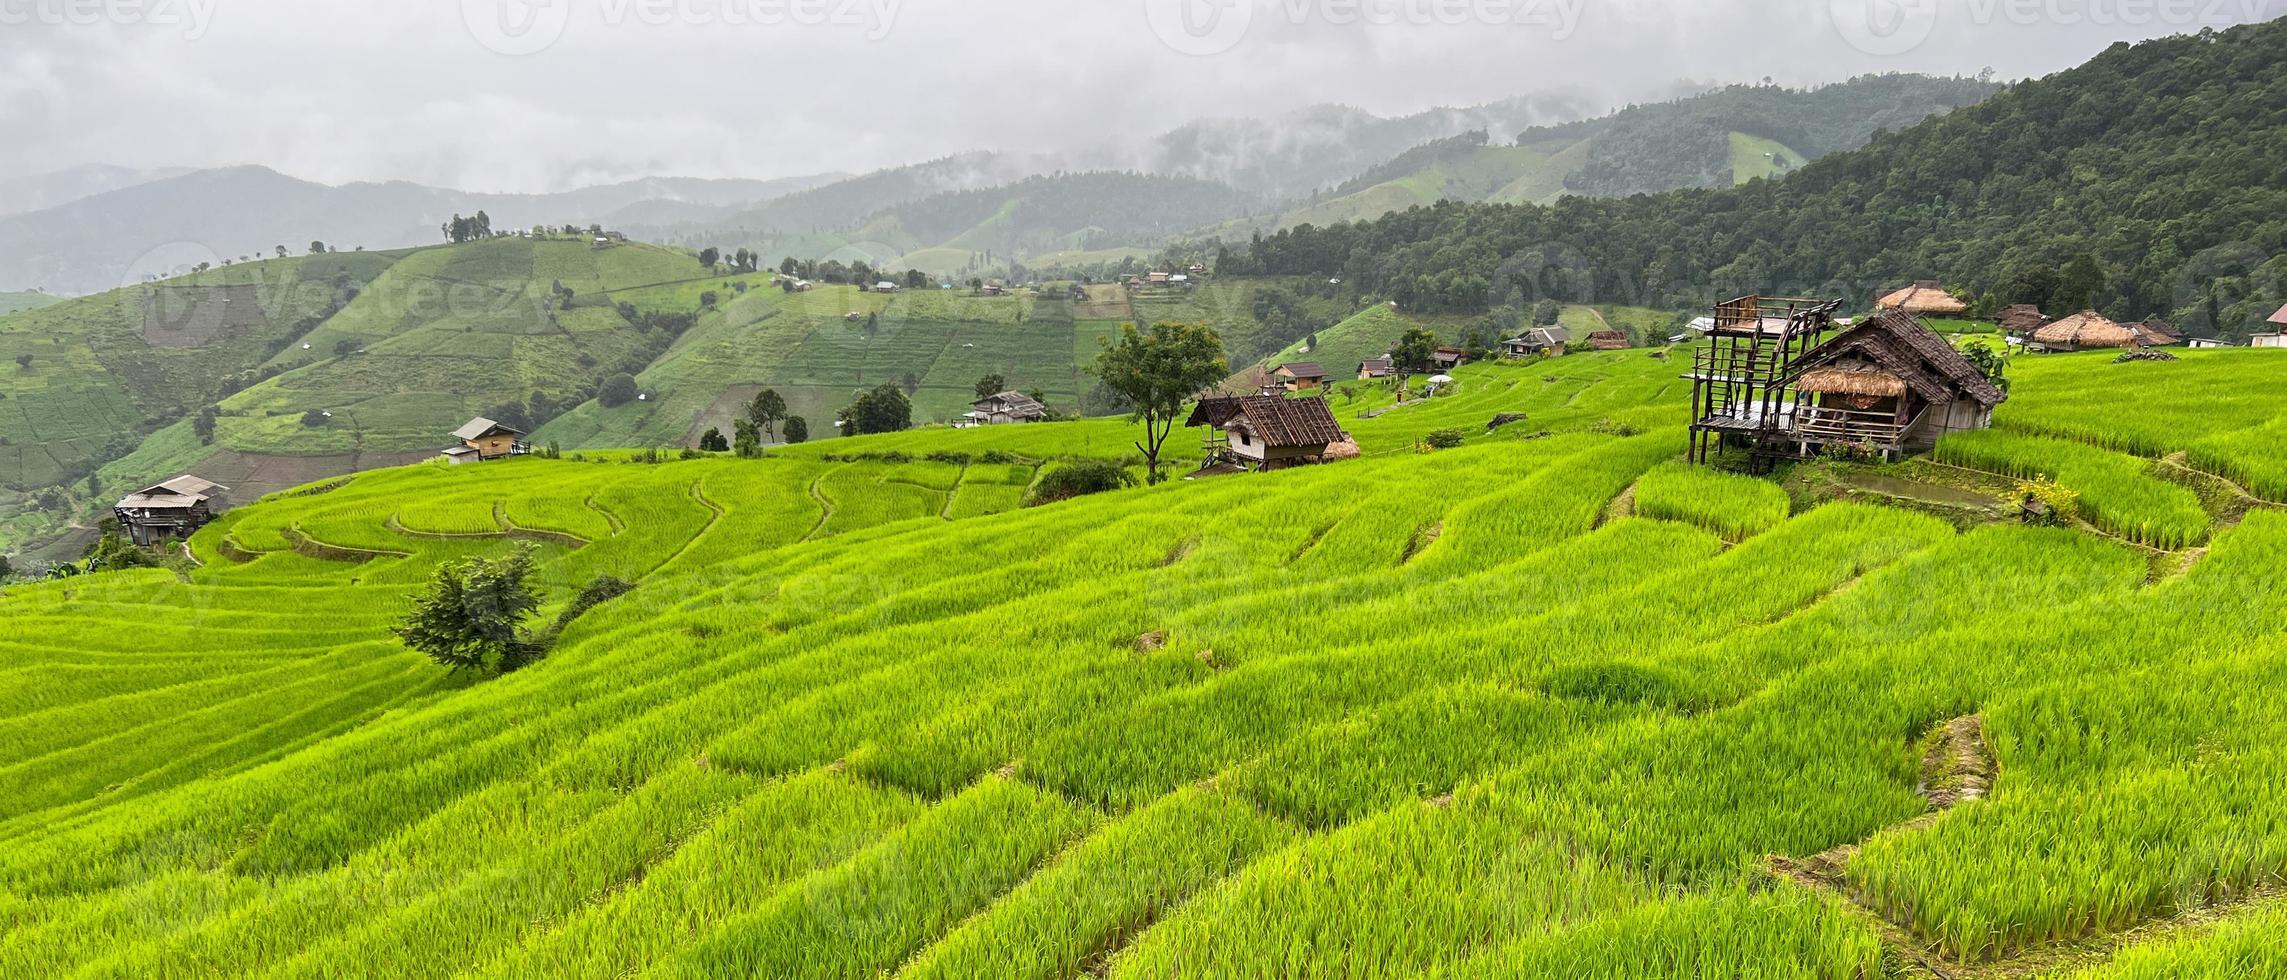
[0,0,2287,192]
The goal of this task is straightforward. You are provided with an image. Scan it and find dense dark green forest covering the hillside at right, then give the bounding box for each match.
[1219,21,2287,336]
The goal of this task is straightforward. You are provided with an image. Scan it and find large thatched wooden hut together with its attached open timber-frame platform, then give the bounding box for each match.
[1686,297,2008,461]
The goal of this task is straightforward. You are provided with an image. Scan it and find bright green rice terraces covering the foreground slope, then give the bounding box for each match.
[0,342,2287,980]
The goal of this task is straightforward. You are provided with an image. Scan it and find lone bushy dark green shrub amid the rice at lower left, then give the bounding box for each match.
[391,544,540,674]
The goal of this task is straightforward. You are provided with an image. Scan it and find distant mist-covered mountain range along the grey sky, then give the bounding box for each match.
[0,75,1992,295]
